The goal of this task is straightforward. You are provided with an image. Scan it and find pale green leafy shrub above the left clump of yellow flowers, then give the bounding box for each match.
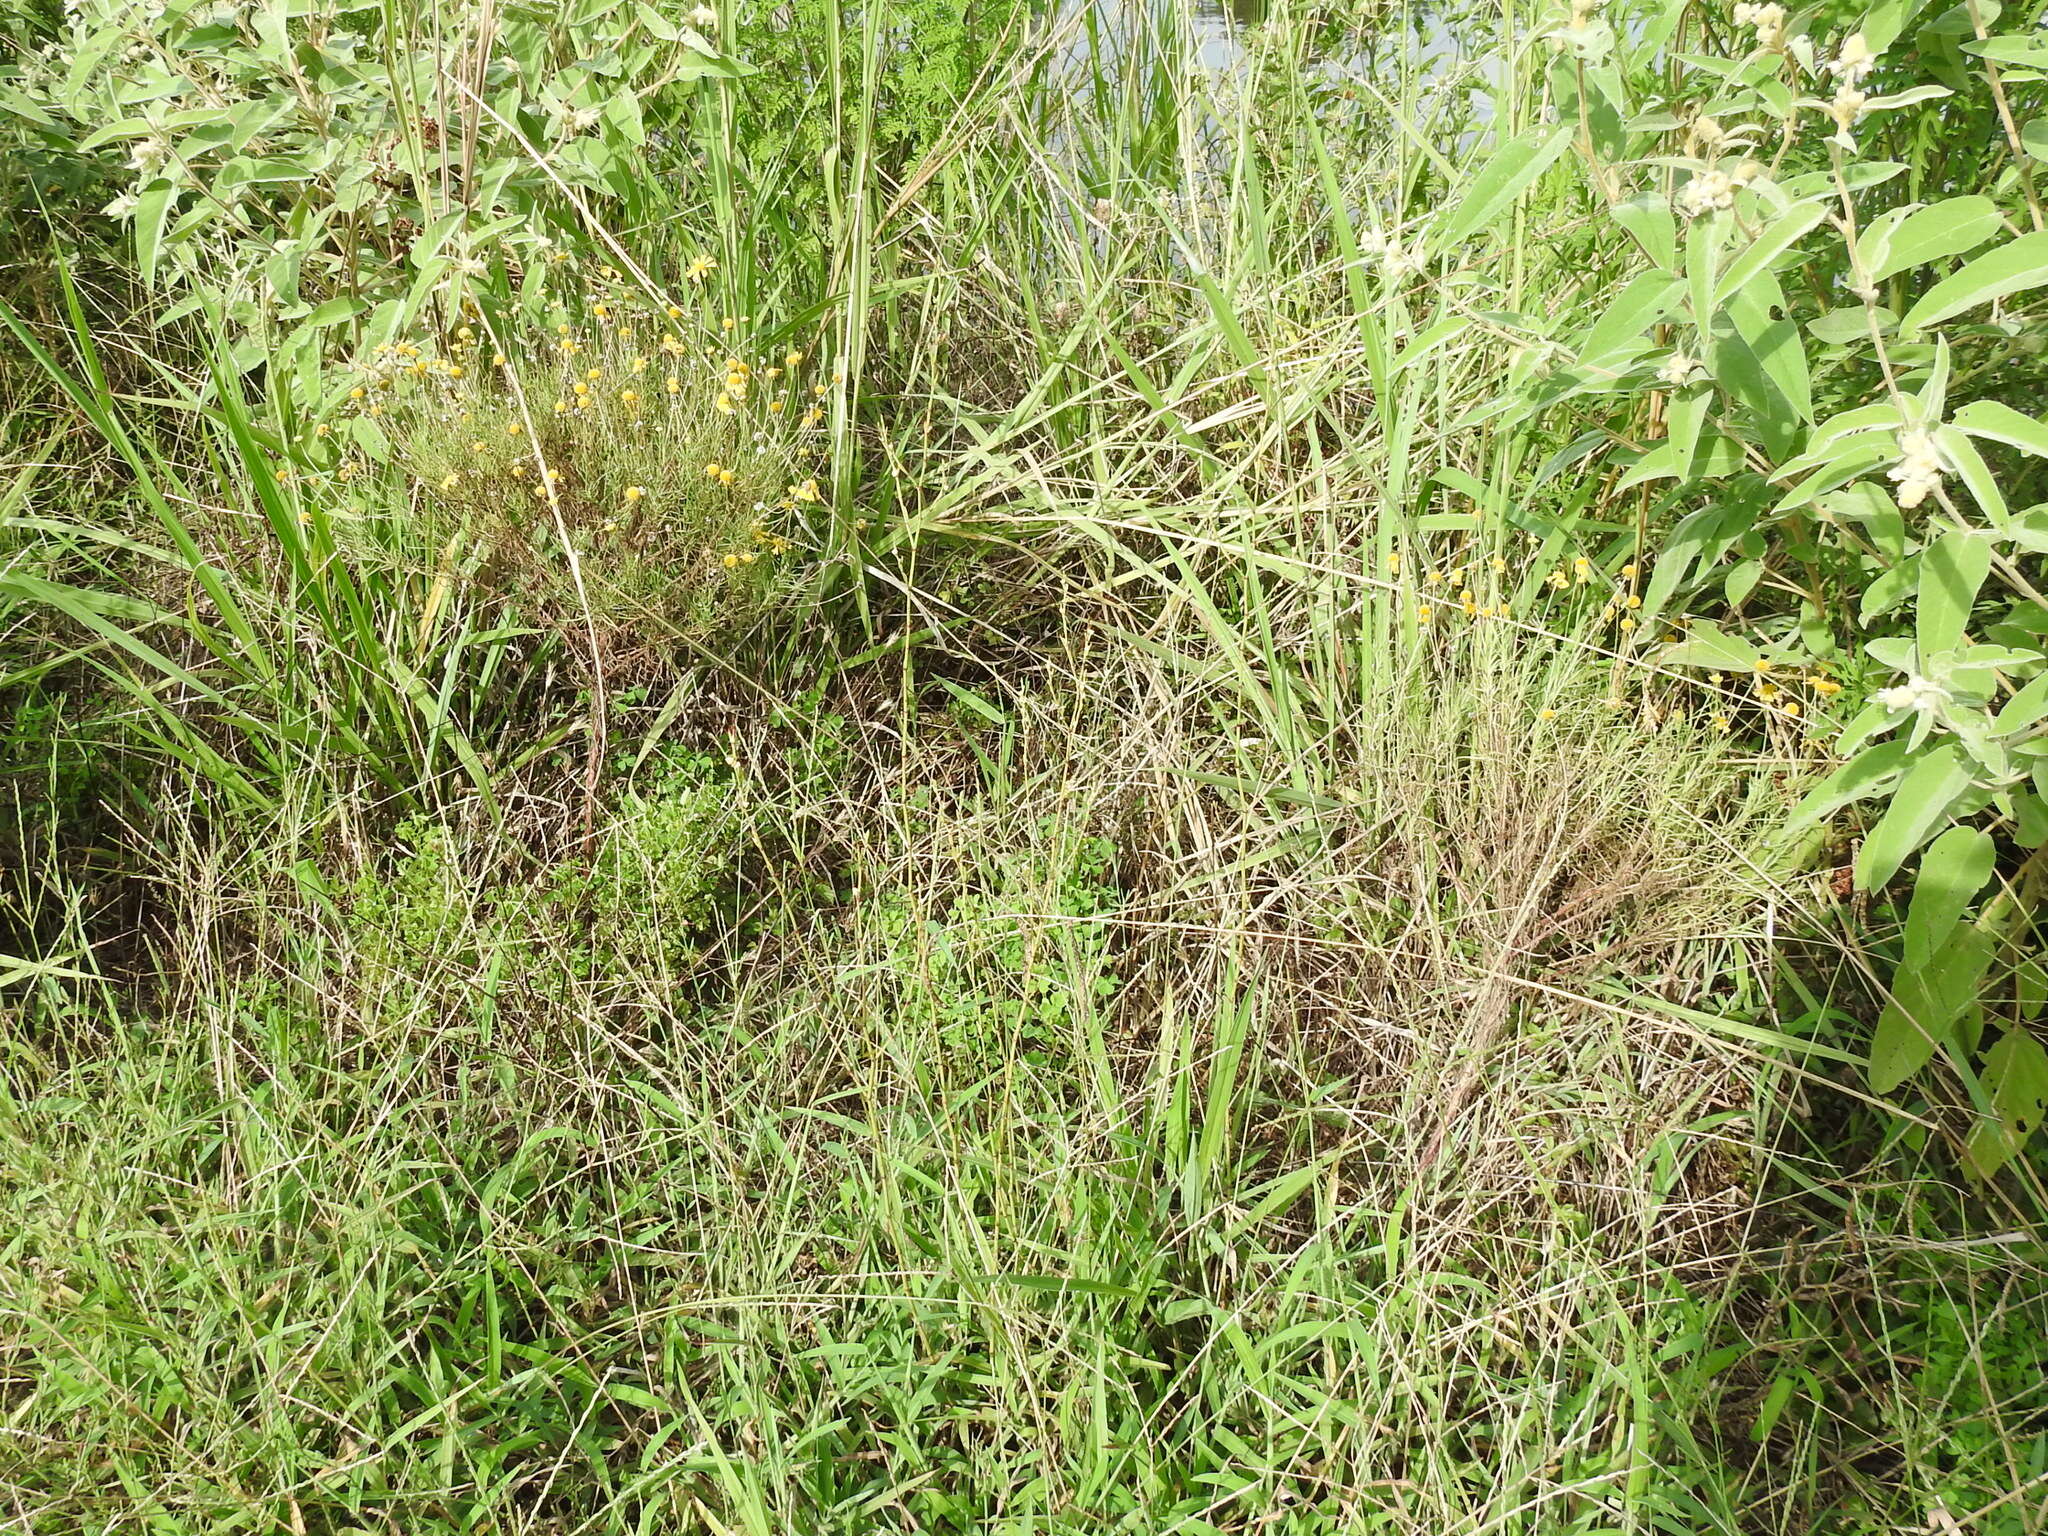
[0,0,743,385]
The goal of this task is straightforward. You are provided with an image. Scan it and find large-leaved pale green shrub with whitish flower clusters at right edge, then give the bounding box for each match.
[1520,0,2048,1176]
